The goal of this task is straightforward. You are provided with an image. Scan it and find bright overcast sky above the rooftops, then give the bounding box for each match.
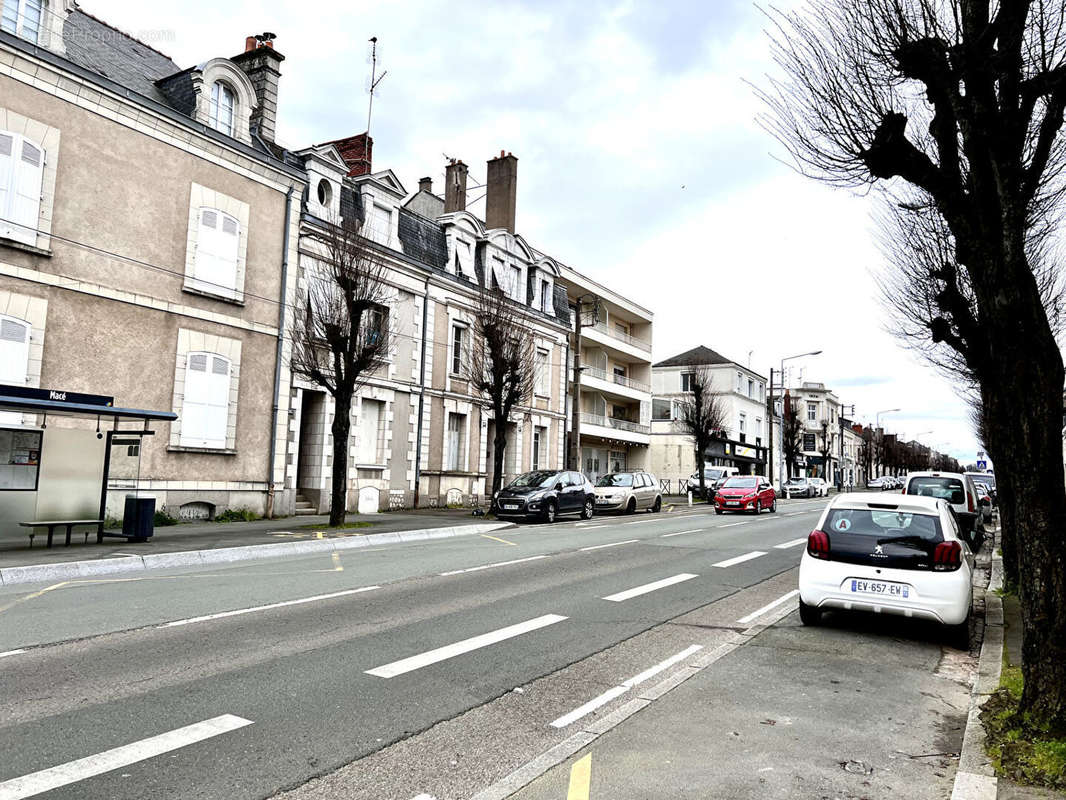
[89,0,978,461]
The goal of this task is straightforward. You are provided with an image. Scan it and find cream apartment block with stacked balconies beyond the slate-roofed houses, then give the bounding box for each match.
[556,269,653,482]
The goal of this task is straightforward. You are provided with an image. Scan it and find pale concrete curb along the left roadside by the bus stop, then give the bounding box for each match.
[0,523,513,586]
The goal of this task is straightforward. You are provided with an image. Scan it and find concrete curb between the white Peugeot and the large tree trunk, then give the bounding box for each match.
[951,529,1003,800]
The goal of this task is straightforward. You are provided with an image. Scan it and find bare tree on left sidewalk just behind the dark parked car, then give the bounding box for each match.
[466,285,537,502]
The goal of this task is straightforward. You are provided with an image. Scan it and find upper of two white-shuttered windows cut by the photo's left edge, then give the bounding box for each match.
[0,131,45,244]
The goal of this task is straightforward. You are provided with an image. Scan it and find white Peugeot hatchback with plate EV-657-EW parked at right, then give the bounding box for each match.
[800,494,974,650]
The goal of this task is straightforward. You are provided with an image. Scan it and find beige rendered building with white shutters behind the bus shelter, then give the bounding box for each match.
[0,10,304,526]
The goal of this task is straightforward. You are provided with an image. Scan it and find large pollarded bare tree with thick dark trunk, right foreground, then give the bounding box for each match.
[762,0,1066,730]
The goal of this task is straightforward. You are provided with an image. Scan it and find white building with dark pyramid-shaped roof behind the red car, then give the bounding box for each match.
[651,346,770,485]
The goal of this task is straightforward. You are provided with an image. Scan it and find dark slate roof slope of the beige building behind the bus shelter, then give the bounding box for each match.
[63,10,181,106]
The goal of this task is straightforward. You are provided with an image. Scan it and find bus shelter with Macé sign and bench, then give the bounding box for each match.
[0,385,177,544]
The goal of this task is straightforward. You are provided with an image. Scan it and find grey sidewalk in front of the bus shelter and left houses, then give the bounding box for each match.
[0,509,487,567]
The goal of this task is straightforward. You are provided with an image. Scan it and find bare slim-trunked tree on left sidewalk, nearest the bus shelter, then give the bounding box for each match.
[290,213,391,527]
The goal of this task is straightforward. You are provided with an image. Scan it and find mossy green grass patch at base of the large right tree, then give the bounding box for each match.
[981,635,1066,789]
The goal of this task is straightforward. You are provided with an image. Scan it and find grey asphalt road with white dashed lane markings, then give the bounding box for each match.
[0,500,950,800]
